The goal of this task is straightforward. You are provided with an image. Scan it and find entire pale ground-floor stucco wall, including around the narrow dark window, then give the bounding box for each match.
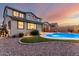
[5,17,42,36]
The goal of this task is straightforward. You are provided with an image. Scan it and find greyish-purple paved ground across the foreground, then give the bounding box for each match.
[0,38,79,56]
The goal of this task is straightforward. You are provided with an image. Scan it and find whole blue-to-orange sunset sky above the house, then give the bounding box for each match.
[0,3,79,26]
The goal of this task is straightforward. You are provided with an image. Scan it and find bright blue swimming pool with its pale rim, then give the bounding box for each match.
[42,33,79,40]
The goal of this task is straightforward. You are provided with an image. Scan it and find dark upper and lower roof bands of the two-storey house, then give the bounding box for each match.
[4,6,43,24]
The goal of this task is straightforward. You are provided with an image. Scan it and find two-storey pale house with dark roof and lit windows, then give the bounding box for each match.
[3,6,43,36]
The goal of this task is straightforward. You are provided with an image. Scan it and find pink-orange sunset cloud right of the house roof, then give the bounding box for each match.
[39,4,79,23]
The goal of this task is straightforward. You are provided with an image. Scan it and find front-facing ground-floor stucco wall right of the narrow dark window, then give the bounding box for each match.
[11,20,42,36]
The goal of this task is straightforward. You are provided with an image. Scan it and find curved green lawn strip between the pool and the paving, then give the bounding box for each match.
[21,36,79,43]
